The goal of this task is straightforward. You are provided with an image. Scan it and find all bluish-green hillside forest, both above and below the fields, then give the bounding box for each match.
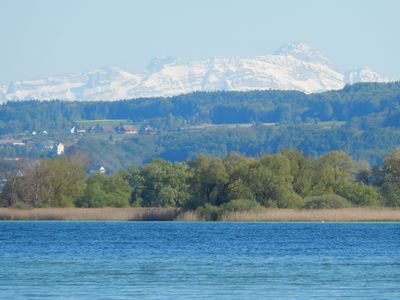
[0,82,400,171]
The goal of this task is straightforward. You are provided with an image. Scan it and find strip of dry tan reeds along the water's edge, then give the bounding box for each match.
[0,207,400,222]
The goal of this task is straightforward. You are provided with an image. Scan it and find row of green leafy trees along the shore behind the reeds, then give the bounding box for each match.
[0,149,400,214]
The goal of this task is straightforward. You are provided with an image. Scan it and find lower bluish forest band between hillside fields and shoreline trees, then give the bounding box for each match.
[68,120,400,170]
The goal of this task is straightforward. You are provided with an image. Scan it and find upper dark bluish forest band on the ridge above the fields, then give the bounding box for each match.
[0,82,400,134]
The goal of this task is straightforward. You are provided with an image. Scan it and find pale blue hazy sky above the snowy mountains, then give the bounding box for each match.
[0,0,400,84]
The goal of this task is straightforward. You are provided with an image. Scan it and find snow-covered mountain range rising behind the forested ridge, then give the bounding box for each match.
[0,43,388,101]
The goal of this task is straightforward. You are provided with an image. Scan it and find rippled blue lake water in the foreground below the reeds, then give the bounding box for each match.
[0,222,400,299]
